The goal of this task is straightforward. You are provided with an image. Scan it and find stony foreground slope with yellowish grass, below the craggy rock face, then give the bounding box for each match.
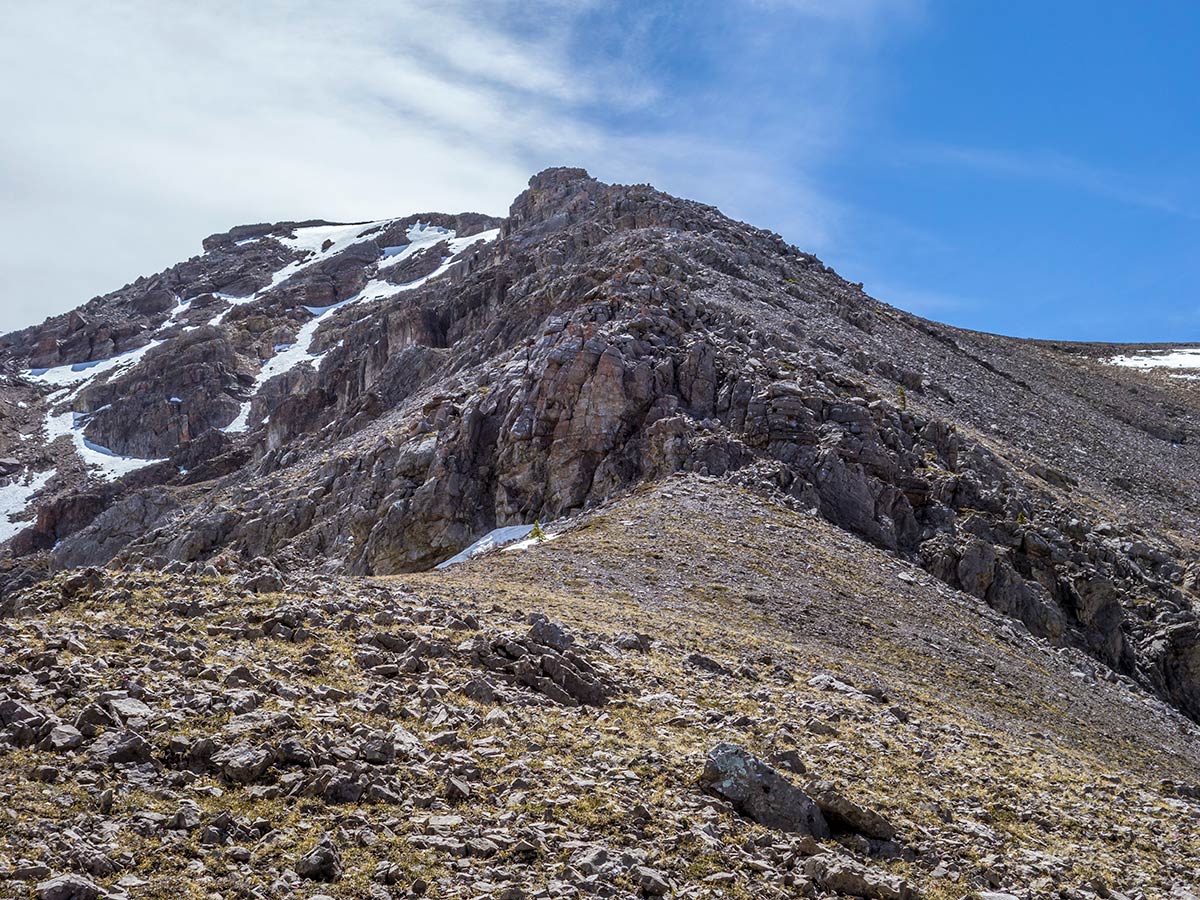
[0,474,1200,900]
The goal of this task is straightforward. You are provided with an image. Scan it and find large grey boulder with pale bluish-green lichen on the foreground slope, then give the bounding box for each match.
[701,743,829,839]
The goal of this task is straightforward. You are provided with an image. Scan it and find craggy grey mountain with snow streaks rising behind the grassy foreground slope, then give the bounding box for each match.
[7,169,1200,716]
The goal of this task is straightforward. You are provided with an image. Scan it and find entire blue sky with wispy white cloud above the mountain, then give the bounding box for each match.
[0,0,1200,342]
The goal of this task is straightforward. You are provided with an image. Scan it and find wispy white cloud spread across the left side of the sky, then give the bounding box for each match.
[0,0,908,331]
